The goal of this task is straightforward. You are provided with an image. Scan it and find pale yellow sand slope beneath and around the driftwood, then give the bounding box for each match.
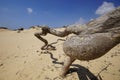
[0,29,120,80]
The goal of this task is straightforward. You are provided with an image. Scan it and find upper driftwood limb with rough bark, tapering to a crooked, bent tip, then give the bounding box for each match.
[35,7,120,49]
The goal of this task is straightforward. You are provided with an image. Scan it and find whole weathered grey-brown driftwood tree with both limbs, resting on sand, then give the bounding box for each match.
[35,7,120,76]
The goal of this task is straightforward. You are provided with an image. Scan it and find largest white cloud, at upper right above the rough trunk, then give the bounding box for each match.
[95,2,115,15]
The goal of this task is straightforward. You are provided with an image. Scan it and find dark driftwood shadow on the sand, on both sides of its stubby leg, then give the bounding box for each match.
[41,51,102,80]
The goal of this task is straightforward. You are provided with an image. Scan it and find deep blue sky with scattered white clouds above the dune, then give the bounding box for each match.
[0,0,120,29]
